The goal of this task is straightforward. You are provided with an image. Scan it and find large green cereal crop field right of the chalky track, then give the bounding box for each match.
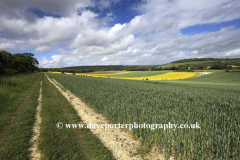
[48,73,240,159]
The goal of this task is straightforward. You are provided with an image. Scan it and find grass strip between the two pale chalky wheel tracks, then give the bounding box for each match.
[39,74,114,160]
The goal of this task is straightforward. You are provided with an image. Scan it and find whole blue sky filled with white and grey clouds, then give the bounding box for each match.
[0,0,240,68]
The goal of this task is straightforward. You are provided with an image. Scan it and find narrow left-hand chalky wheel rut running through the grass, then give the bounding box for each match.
[29,81,42,160]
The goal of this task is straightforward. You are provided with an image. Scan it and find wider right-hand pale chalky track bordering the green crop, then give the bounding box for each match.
[47,76,169,160]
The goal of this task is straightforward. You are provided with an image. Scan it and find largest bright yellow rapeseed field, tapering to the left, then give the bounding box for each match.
[102,72,198,80]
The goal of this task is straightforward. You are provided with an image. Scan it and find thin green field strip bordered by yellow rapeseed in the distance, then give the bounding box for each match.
[109,71,172,77]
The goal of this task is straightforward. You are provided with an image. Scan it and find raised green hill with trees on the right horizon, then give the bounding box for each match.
[157,58,240,70]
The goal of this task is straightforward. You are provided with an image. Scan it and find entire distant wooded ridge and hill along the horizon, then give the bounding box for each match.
[40,58,240,73]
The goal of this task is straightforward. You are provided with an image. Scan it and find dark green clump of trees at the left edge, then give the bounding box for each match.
[0,50,39,74]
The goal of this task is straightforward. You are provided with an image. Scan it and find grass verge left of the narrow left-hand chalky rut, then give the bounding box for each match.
[0,73,41,159]
